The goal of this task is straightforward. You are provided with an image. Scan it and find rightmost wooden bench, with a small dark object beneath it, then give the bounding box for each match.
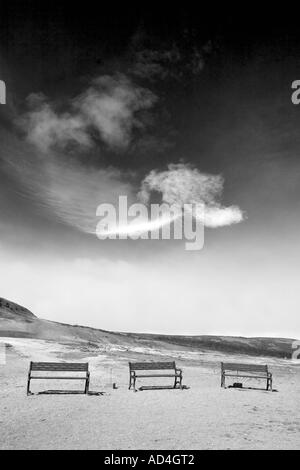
[221,362,273,391]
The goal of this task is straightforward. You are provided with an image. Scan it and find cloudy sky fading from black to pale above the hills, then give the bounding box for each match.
[0,1,300,338]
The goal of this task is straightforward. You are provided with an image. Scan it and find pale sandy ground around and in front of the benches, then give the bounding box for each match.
[0,338,300,450]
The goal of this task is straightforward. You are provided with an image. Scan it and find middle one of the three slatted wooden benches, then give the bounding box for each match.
[129,361,182,390]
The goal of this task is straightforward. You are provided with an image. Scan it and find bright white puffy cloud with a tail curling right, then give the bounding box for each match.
[138,163,244,228]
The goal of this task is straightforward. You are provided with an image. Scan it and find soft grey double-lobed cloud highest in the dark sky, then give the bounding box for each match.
[18,75,157,152]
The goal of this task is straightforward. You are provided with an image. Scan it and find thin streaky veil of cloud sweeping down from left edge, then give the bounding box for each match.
[2,141,134,234]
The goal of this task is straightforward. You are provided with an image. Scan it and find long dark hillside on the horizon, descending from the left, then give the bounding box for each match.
[0,298,293,358]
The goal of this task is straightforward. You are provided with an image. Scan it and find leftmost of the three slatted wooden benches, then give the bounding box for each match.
[27,362,90,395]
